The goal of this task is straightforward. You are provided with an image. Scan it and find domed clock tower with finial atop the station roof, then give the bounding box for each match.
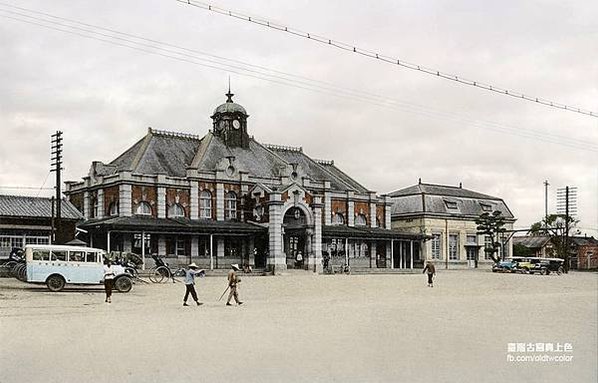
[211,88,249,149]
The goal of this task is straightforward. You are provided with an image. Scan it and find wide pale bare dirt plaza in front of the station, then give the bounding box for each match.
[0,270,598,383]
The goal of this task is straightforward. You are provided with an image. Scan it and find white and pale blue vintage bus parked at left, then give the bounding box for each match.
[25,245,133,292]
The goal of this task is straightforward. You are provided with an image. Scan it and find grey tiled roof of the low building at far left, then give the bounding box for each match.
[0,195,83,220]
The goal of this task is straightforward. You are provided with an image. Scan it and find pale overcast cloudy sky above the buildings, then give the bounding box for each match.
[0,0,598,236]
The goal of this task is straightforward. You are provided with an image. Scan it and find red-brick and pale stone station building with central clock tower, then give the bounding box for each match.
[65,91,425,271]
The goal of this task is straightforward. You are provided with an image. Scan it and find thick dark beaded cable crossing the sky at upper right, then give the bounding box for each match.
[176,0,598,118]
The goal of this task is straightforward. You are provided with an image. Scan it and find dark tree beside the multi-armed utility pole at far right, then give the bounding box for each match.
[530,214,579,272]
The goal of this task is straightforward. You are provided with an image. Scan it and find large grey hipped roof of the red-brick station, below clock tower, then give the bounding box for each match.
[93,128,368,193]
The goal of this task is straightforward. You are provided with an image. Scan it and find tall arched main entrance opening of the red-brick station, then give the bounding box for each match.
[282,206,311,269]
